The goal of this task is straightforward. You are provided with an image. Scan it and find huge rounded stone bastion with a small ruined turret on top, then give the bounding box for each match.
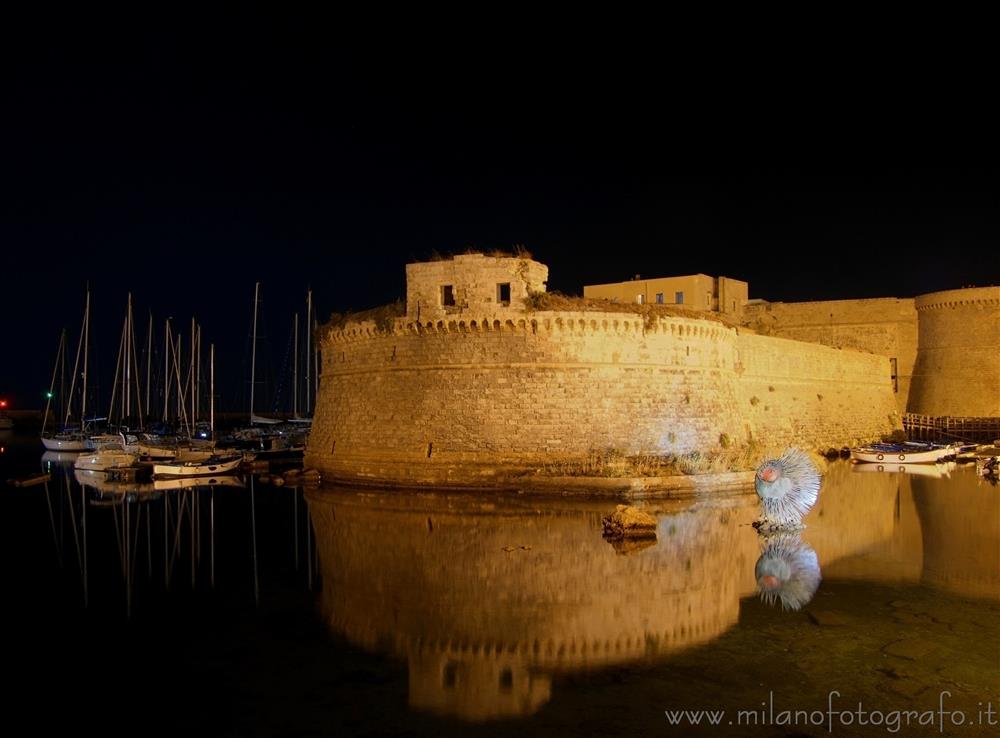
[306,254,952,486]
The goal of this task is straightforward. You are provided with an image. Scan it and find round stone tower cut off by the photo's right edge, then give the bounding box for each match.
[909,287,1000,418]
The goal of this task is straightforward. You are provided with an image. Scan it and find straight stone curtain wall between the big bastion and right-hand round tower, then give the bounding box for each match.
[744,297,917,413]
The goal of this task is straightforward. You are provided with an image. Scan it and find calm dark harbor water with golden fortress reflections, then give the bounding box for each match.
[0,426,1000,736]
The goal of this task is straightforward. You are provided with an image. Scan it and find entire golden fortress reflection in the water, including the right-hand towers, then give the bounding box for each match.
[306,464,1000,721]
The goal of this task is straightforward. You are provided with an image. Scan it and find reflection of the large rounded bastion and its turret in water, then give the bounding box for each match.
[308,492,758,718]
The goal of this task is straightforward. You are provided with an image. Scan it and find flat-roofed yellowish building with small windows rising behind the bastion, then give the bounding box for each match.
[583,274,749,315]
